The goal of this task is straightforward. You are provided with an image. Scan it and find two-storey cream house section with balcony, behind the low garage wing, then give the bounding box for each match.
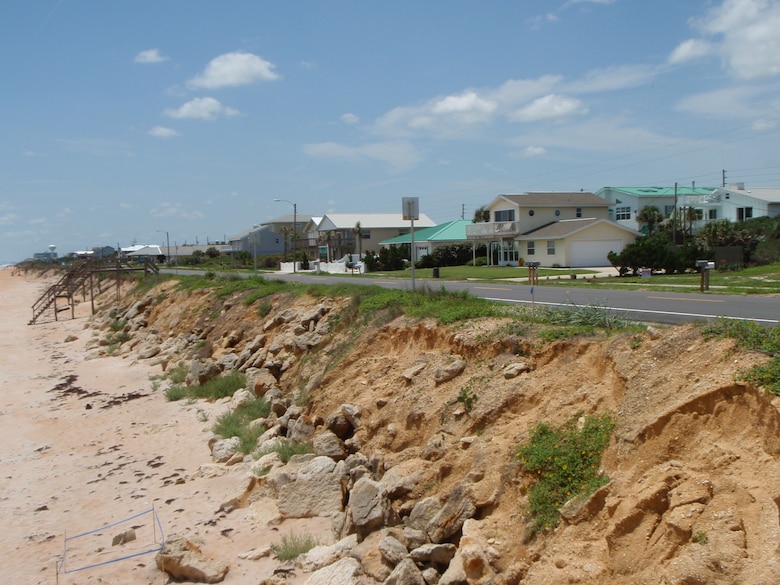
[466,192,620,266]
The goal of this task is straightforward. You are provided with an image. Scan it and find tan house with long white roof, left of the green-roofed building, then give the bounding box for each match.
[313,213,436,260]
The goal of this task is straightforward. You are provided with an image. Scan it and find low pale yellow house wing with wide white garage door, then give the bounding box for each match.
[517,217,641,267]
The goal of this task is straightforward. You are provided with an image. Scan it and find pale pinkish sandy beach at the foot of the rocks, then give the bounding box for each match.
[0,269,328,585]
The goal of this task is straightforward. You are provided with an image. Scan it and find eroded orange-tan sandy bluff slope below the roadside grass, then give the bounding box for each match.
[93,282,780,585]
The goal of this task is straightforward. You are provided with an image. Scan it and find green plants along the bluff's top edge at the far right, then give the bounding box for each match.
[702,319,780,396]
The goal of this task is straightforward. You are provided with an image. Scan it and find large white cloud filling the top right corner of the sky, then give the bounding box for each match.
[669,0,780,80]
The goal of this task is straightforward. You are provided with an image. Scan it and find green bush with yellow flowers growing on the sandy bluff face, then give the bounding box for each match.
[517,413,615,533]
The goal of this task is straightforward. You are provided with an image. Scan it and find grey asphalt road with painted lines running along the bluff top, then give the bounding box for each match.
[165,271,780,326]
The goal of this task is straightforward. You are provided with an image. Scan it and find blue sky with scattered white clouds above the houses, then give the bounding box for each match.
[0,0,780,261]
